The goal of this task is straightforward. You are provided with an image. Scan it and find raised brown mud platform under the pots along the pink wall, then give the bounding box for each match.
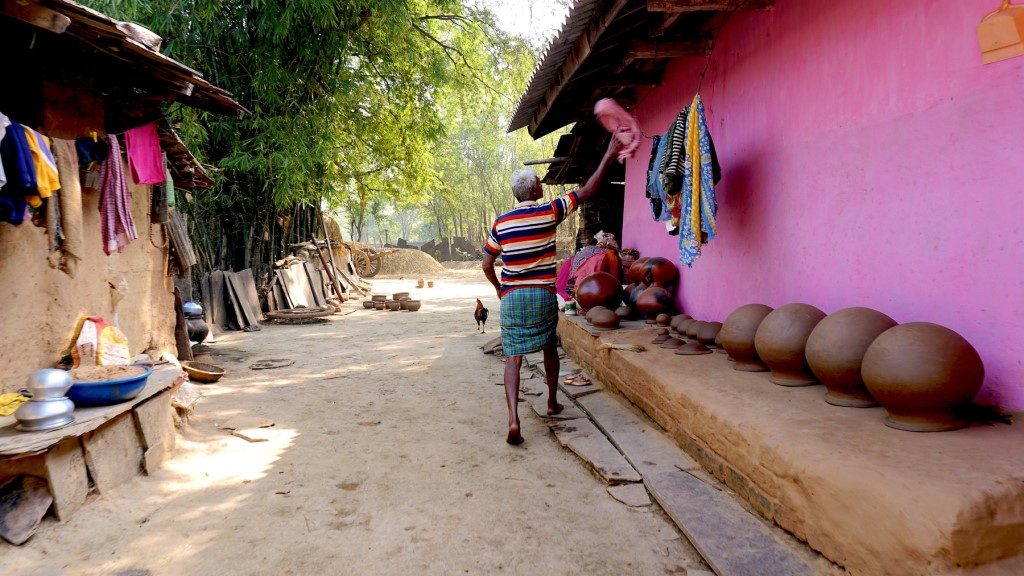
[558,313,1024,576]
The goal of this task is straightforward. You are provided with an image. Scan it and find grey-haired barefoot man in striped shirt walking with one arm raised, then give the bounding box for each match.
[483,138,621,445]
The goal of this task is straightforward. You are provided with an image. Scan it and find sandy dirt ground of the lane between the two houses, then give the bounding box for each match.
[8,275,702,576]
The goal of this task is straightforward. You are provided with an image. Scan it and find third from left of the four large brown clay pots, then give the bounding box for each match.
[807,307,896,408]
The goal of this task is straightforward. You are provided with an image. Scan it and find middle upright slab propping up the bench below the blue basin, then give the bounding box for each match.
[82,414,142,494]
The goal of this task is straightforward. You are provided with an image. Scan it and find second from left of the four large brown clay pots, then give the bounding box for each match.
[754,303,825,386]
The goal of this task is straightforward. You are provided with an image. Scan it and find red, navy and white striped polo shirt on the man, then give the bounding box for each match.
[483,192,580,296]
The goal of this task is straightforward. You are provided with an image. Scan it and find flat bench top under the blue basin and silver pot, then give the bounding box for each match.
[0,366,185,459]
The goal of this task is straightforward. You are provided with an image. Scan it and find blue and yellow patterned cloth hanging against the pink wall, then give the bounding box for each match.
[679,94,718,266]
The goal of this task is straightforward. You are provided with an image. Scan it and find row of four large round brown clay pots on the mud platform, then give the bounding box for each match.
[720,303,985,431]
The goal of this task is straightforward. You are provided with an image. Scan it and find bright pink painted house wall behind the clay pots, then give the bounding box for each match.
[623,0,1024,410]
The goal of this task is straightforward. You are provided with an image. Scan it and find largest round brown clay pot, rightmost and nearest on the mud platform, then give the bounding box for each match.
[860,322,985,431]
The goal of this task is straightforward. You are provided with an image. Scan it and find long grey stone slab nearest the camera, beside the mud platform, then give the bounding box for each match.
[644,470,818,576]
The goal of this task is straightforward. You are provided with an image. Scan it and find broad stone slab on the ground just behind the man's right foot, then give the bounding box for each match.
[578,393,702,476]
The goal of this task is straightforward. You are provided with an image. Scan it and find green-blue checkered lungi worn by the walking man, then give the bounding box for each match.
[502,288,558,356]
